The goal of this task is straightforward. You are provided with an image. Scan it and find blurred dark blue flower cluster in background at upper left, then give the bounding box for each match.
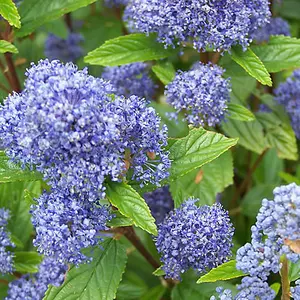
[45,33,84,62]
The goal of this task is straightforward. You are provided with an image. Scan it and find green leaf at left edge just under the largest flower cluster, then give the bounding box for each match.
[0,151,42,183]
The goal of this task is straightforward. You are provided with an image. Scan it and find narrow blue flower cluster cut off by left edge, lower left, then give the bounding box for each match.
[0,208,15,274]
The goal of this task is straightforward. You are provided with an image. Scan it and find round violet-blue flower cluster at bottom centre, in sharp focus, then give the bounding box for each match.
[155,199,233,280]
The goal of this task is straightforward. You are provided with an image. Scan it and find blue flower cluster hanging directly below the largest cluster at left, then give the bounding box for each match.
[32,190,112,265]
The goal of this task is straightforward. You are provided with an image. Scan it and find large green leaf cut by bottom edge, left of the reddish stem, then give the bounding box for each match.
[44,239,127,300]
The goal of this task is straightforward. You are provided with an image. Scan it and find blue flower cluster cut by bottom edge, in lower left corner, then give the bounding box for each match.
[5,258,67,300]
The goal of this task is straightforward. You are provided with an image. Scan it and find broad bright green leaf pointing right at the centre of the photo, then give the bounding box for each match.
[169,128,237,180]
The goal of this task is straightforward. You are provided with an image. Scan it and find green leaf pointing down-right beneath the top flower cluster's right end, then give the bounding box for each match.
[231,46,272,86]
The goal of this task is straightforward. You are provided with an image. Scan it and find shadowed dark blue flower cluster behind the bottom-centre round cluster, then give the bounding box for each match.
[144,186,174,224]
